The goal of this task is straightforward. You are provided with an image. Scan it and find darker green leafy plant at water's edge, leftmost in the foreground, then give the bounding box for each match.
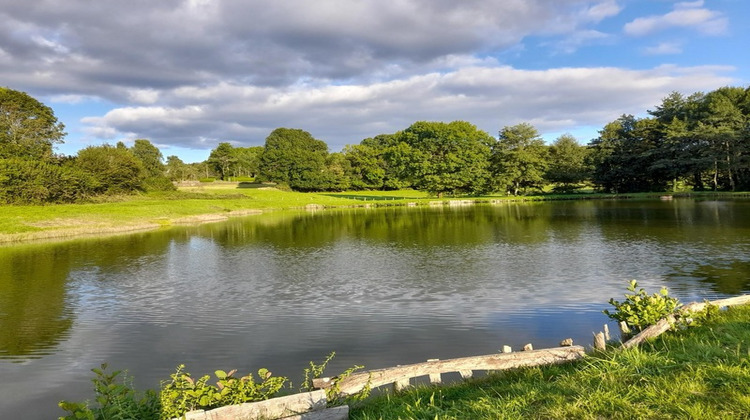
[58,363,160,420]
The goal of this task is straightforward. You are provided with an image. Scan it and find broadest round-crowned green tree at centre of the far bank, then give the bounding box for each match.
[390,121,494,196]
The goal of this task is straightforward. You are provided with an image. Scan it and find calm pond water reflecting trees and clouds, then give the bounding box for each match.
[0,199,750,418]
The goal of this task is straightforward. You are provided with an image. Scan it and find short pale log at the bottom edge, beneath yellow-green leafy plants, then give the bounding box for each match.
[178,390,326,420]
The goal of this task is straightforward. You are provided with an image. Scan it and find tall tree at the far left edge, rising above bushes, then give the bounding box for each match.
[0,87,66,161]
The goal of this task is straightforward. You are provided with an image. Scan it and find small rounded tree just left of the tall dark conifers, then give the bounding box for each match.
[545,134,591,191]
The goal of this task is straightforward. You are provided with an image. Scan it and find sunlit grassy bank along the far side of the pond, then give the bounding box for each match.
[0,183,747,243]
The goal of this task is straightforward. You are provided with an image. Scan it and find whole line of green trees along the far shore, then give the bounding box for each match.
[0,87,750,203]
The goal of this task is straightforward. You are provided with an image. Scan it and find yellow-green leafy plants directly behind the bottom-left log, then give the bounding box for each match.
[159,365,287,419]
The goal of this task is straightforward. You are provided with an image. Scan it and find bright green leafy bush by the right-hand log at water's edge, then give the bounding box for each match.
[603,280,682,331]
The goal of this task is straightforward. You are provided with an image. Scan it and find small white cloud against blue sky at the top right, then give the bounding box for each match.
[624,1,729,36]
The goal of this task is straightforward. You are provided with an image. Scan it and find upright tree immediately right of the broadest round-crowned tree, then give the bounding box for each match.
[492,123,548,195]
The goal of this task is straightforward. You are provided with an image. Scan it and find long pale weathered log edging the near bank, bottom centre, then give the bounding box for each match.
[323,346,585,395]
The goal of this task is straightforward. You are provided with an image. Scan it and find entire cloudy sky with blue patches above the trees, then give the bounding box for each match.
[0,0,750,162]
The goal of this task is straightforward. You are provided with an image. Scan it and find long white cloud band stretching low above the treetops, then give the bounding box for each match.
[86,66,731,150]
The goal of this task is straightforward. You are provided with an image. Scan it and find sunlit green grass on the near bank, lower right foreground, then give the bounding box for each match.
[350,305,750,420]
